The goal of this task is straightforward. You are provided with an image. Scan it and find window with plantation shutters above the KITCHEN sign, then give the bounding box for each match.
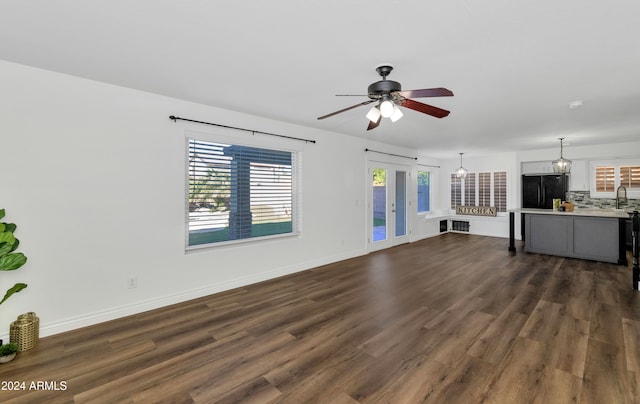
[451,171,507,212]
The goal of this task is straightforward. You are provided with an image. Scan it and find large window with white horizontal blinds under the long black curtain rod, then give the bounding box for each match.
[187,139,297,246]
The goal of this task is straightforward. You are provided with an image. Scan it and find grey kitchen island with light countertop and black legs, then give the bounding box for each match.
[509,209,628,265]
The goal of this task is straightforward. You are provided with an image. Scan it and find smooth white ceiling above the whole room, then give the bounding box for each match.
[0,0,640,158]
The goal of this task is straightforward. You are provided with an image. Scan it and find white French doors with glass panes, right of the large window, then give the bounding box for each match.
[368,162,409,250]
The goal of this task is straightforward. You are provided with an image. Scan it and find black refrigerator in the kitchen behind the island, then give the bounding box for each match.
[522,174,569,209]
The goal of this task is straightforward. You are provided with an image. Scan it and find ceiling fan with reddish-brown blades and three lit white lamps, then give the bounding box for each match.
[318,65,453,130]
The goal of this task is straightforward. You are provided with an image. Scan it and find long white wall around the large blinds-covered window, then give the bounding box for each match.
[0,61,450,338]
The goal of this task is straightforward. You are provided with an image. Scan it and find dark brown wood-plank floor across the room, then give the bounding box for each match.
[0,234,640,404]
